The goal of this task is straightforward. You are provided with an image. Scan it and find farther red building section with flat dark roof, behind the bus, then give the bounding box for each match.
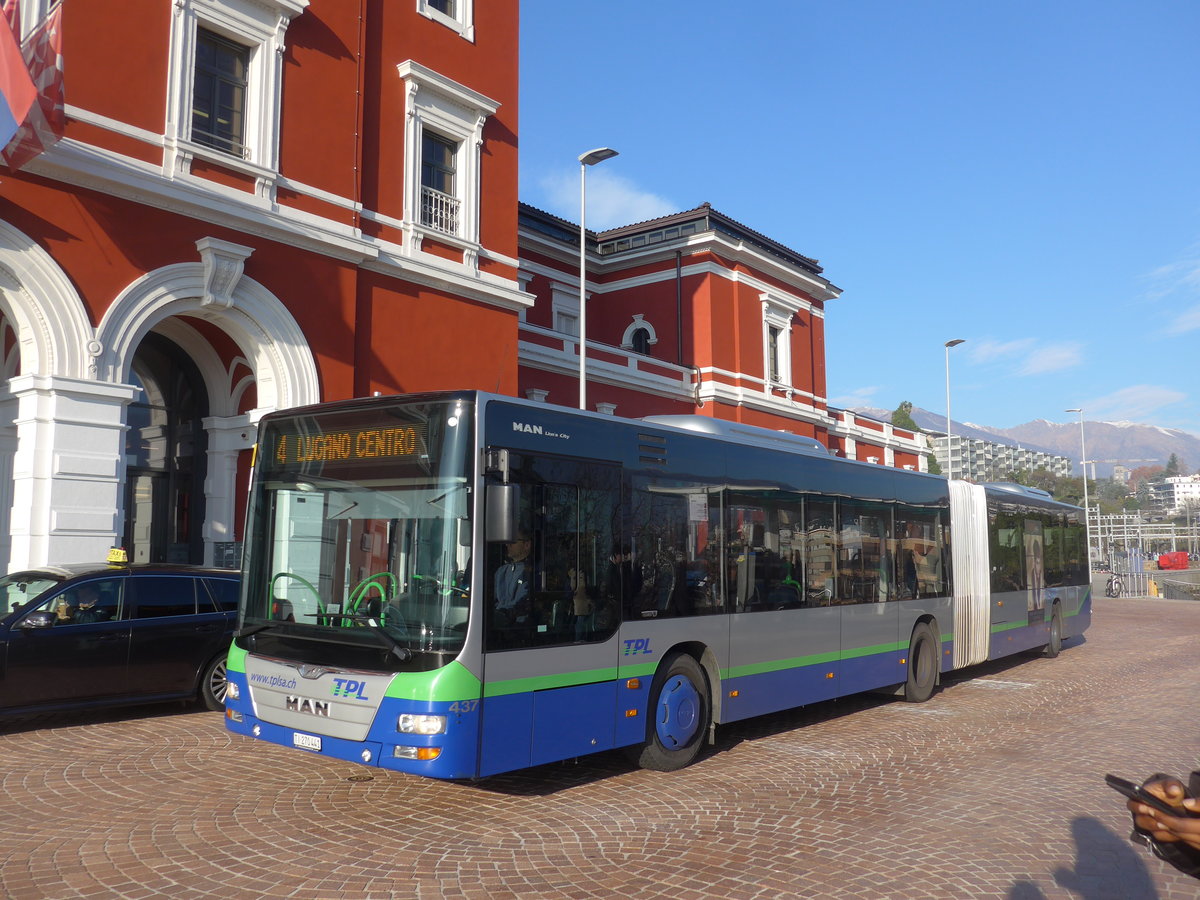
[520,204,928,470]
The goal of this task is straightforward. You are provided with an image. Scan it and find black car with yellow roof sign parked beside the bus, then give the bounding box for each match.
[0,565,240,715]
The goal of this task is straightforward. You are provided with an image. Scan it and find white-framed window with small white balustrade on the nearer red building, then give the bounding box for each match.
[397,60,499,246]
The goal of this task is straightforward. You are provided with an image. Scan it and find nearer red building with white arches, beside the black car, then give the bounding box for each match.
[0,0,528,569]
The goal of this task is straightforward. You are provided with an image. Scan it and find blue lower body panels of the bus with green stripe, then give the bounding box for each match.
[226,587,1091,779]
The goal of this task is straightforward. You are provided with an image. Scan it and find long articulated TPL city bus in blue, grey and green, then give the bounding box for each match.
[226,391,1091,779]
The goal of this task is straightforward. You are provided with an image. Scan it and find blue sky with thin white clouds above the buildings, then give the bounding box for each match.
[520,0,1200,433]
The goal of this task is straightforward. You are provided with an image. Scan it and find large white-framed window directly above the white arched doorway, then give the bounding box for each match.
[166,0,308,172]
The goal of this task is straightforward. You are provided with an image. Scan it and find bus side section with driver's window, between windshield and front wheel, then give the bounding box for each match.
[480,454,620,775]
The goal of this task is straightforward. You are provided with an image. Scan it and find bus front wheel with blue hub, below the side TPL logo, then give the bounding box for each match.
[635,653,712,772]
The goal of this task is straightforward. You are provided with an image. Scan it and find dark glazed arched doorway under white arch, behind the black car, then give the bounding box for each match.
[124,334,209,565]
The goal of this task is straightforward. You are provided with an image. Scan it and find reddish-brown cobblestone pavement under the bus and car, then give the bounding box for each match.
[0,598,1200,900]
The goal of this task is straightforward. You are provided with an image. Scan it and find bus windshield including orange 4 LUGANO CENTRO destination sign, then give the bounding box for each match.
[242,400,472,660]
